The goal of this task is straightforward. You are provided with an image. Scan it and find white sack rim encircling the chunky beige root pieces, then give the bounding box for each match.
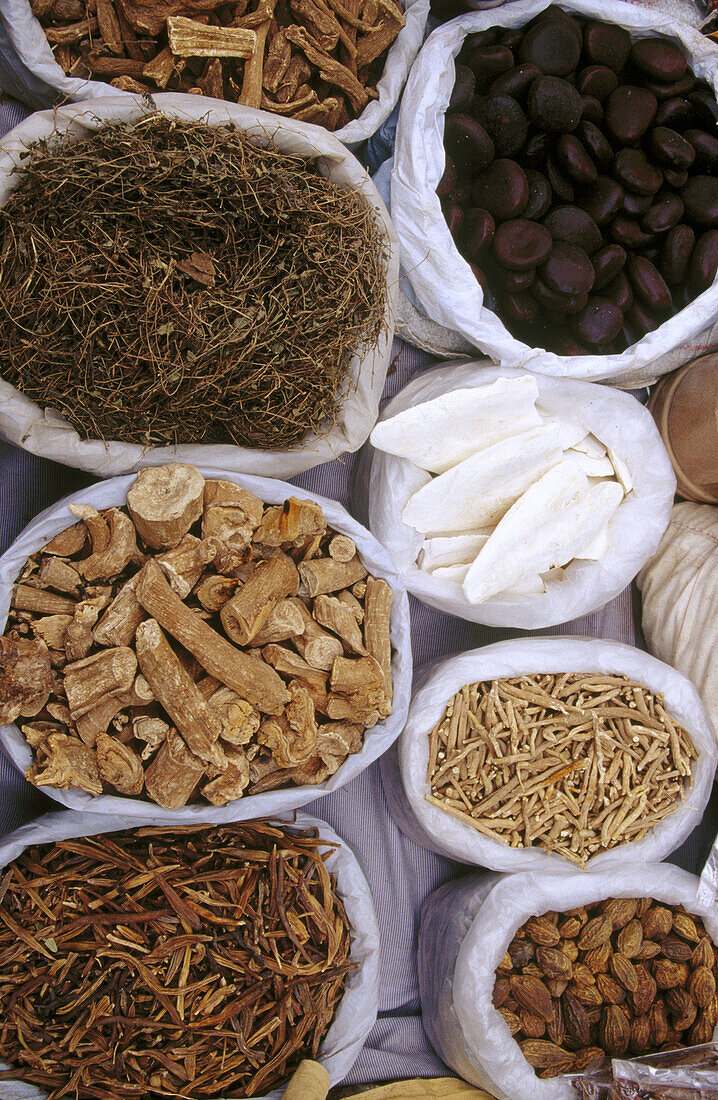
[0,466,412,825]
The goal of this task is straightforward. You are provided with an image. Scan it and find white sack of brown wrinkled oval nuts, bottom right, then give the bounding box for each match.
[418,862,718,1100]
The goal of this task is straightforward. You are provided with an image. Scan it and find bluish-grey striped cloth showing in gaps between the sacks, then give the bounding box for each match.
[0,96,718,1085]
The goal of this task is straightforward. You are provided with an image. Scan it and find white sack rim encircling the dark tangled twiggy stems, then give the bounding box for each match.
[0,100,399,477]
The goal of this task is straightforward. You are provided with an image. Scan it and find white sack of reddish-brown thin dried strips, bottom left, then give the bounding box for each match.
[0,812,379,1100]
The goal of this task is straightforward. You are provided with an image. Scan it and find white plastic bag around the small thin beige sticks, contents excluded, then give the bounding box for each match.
[382,637,718,877]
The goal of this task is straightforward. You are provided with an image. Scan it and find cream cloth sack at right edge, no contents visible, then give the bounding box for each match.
[638,502,718,743]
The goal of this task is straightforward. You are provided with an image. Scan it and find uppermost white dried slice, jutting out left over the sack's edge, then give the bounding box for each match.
[371,374,542,473]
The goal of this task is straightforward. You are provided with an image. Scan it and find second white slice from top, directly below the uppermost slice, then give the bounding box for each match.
[401,421,572,536]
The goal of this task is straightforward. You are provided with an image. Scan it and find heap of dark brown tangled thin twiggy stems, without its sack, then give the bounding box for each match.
[0,114,386,448]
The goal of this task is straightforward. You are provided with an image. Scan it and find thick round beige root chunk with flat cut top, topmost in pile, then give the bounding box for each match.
[128,462,204,550]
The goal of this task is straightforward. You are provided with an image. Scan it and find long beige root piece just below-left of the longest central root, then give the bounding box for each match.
[136,619,223,767]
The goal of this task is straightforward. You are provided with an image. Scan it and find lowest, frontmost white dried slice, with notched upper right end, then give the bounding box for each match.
[463,462,623,604]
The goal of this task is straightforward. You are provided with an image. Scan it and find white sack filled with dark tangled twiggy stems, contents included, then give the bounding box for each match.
[0,95,398,476]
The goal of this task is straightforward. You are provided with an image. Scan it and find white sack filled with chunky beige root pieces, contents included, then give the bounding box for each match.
[0,463,411,822]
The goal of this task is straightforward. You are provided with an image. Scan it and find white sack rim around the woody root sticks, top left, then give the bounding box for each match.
[0,0,429,146]
